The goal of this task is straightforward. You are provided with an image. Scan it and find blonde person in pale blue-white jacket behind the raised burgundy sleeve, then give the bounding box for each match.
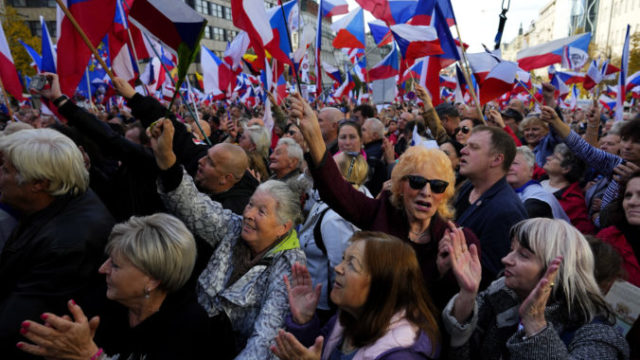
[300,152,371,323]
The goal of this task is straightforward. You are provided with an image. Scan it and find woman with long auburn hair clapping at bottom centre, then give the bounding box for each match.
[272,232,440,360]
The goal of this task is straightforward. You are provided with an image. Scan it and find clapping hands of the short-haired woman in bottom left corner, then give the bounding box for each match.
[16,300,100,360]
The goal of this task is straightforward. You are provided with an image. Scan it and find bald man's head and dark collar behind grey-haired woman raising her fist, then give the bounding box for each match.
[194,143,259,215]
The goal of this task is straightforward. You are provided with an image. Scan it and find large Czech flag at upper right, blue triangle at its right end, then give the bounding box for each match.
[517,33,591,71]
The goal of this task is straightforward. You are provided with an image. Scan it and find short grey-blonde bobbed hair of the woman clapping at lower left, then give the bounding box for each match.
[106,213,196,293]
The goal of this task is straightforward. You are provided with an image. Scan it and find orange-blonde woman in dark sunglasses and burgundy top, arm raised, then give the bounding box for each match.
[290,95,478,307]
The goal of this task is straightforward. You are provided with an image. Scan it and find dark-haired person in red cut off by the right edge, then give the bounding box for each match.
[597,172,640,286]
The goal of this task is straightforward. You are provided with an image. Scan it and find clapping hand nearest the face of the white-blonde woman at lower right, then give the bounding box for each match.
[519,256,562,336]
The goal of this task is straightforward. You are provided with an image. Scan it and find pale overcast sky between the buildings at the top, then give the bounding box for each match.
[342,0,548,52]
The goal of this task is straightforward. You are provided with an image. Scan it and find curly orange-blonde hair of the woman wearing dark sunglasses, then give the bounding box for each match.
[391,146,456,219]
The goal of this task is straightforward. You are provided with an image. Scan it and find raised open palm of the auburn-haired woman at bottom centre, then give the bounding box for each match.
[284,262,322,324]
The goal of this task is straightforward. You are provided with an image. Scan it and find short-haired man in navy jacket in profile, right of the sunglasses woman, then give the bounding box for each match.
[454,126,527,285]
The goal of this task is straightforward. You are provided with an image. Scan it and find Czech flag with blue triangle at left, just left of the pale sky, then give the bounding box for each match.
[391,24,443,61]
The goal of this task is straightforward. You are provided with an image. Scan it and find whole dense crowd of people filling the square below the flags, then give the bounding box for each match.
[0,74,640,360]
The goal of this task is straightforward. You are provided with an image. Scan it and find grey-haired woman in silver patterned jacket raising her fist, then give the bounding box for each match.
[151,119,305,360]
